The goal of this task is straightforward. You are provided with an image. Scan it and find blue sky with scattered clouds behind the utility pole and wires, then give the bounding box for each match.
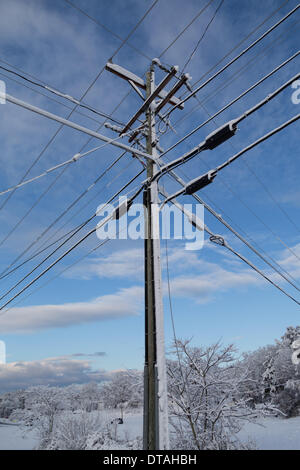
[0,0,300,392]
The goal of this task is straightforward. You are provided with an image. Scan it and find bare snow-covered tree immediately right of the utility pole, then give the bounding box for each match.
[167,341,254,450]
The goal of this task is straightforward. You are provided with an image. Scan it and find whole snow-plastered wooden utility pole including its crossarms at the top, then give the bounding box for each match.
[105,59,186,450]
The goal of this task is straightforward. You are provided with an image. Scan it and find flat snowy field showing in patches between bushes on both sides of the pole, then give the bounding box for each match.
[0,412,300,450]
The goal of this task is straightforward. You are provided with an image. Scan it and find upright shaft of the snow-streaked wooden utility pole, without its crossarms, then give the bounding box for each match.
[143,64,169,450]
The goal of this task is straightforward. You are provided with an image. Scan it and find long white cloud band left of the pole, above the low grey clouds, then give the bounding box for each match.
[0,287,143,334]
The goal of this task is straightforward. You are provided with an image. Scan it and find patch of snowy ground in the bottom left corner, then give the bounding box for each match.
[0,419,38,450]
